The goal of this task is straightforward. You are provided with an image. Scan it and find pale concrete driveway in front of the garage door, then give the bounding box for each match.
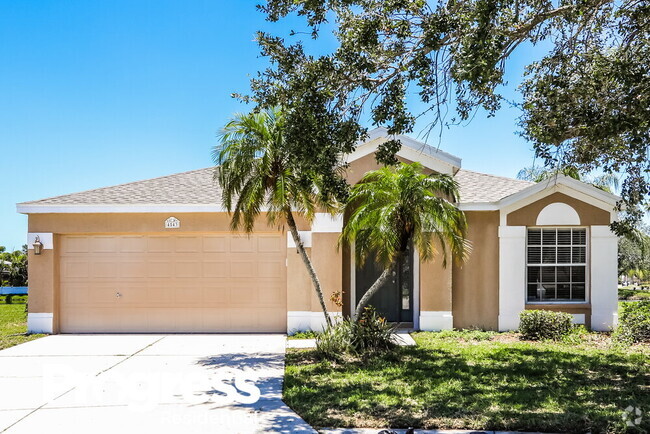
[0,335,314,433]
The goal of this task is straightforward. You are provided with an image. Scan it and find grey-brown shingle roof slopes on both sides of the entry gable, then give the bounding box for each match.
[20,167,533,206]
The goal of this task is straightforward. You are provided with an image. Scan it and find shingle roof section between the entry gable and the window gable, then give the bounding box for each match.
[454,169,535,203]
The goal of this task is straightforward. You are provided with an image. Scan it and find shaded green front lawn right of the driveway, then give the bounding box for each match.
[284,332,650,432]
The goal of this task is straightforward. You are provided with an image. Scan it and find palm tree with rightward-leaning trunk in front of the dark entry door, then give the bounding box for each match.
[339,163,469,318]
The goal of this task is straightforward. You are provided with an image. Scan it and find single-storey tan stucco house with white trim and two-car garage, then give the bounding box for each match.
[18,129,617,333]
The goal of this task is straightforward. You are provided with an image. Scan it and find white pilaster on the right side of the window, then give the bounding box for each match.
[590,226,618,331]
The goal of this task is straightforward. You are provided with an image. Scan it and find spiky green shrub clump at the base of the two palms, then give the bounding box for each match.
[316,307,397,360]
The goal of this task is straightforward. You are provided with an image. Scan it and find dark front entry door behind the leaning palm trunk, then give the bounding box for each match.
[355,249,413,322]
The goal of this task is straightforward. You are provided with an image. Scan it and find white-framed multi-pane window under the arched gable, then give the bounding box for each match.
[526,228,587,302]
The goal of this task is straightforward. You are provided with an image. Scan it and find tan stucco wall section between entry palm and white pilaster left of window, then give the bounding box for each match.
[452,211,502,330]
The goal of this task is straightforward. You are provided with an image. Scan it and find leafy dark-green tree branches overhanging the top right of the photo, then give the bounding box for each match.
[244,0,650,233]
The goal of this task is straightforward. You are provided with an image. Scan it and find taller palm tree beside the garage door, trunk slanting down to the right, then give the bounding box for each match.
[213,108,335,326]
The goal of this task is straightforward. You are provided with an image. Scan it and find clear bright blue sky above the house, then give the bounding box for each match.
[0,0,535,250]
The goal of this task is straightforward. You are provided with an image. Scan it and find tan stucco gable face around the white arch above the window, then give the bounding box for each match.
[507,193,610,226]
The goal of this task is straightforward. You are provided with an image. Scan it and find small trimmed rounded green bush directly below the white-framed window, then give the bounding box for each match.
[519,310,573,341]
